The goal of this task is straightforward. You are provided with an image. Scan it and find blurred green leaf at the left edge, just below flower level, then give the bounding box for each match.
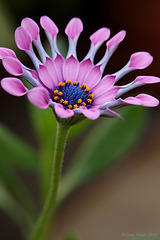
[0,124,37,170]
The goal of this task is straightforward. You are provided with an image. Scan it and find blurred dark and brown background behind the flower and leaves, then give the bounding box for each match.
[0,0,160,240]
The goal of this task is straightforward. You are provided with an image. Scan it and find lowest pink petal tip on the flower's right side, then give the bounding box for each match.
[121,94,159,107]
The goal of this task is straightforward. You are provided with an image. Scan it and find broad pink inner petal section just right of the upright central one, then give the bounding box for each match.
[76,59,93,84]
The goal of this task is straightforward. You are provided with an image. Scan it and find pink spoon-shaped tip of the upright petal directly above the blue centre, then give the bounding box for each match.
[65,18,83,40]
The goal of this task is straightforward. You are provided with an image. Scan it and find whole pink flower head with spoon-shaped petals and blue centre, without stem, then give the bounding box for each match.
[0,16,160,120]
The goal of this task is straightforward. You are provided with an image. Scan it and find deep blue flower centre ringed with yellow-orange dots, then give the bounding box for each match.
[51,80,94,109]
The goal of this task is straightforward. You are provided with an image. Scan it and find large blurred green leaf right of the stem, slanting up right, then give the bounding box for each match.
[58,106,146,201]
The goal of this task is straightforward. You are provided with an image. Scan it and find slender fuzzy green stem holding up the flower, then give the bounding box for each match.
[30,123,70,240]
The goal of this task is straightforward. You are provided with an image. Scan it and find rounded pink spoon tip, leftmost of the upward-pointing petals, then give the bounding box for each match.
[15,27,32,50]
